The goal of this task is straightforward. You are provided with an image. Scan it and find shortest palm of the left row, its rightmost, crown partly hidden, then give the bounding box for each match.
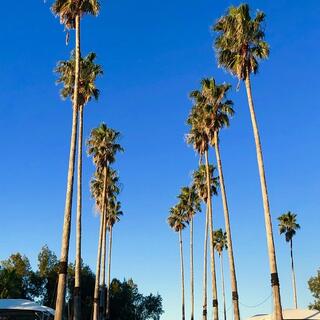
[106,196,123,320]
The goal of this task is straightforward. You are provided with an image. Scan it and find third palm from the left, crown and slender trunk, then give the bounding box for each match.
[87,123,123,320]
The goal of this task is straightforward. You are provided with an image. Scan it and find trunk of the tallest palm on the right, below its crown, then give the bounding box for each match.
[245,75,283,320]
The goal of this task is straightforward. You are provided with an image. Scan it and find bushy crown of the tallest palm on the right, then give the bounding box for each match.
[213,4,269,80]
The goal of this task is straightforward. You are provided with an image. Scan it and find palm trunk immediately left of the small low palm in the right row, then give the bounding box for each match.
[205,150,219,320]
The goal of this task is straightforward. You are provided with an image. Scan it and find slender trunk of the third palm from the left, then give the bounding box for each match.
[93,167,107,320]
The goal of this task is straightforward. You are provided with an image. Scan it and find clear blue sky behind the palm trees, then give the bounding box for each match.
[0,0,320,320]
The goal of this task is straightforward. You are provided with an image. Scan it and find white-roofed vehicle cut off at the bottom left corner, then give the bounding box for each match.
[0,299,54,320]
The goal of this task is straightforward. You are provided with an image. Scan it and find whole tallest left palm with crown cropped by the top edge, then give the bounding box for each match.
[51,0,100,320]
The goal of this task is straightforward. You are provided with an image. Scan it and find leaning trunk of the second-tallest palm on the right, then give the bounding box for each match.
[214,132,240,320]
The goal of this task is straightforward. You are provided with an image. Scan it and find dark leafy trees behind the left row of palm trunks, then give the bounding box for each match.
[0,246,163,320]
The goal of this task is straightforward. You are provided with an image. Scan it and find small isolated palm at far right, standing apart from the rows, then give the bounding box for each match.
[278,211,300,309]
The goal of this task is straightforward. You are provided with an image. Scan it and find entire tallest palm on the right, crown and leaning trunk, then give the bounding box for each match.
[213,4,282,320]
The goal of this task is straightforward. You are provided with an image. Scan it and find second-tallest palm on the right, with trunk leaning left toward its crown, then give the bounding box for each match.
[192,78,240,320]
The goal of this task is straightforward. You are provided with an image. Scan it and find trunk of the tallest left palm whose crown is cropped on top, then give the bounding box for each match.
[54,15,80,320]
